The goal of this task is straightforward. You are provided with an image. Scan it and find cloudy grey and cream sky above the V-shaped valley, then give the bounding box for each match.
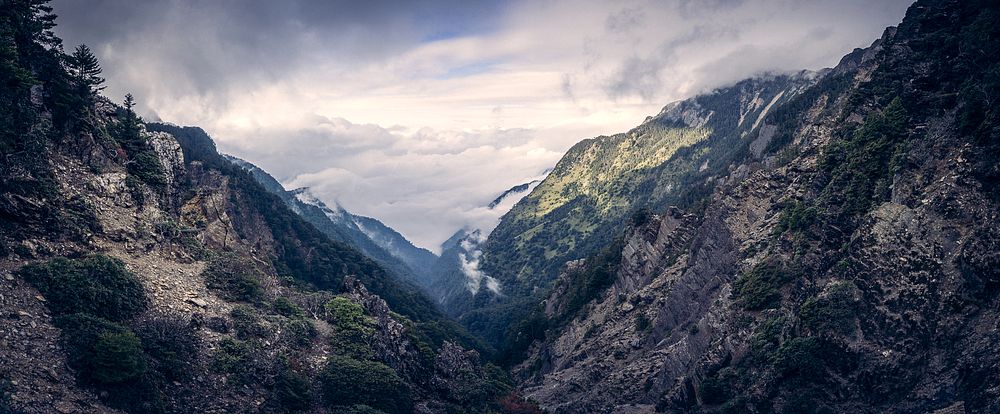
[52,0,910,251]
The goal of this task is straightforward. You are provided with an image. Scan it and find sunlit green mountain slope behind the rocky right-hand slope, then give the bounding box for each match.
[456,71,828,344]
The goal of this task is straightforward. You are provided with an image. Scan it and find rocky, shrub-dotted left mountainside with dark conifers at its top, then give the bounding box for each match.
[0,1,525,413]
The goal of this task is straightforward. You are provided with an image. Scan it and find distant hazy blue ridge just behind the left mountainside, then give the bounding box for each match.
[217,152,438,289]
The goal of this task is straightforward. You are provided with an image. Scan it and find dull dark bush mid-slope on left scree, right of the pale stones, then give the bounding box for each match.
[202,254,264,302]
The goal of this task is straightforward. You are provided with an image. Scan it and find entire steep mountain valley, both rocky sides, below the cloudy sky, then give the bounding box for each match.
[0,0,1000,414]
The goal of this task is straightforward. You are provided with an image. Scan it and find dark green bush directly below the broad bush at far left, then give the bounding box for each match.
[56,313,148,384]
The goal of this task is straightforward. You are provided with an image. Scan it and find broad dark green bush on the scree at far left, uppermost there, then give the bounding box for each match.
[18,255,146,321]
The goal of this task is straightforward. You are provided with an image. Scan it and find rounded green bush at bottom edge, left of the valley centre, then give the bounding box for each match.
[320,356,412,413]
